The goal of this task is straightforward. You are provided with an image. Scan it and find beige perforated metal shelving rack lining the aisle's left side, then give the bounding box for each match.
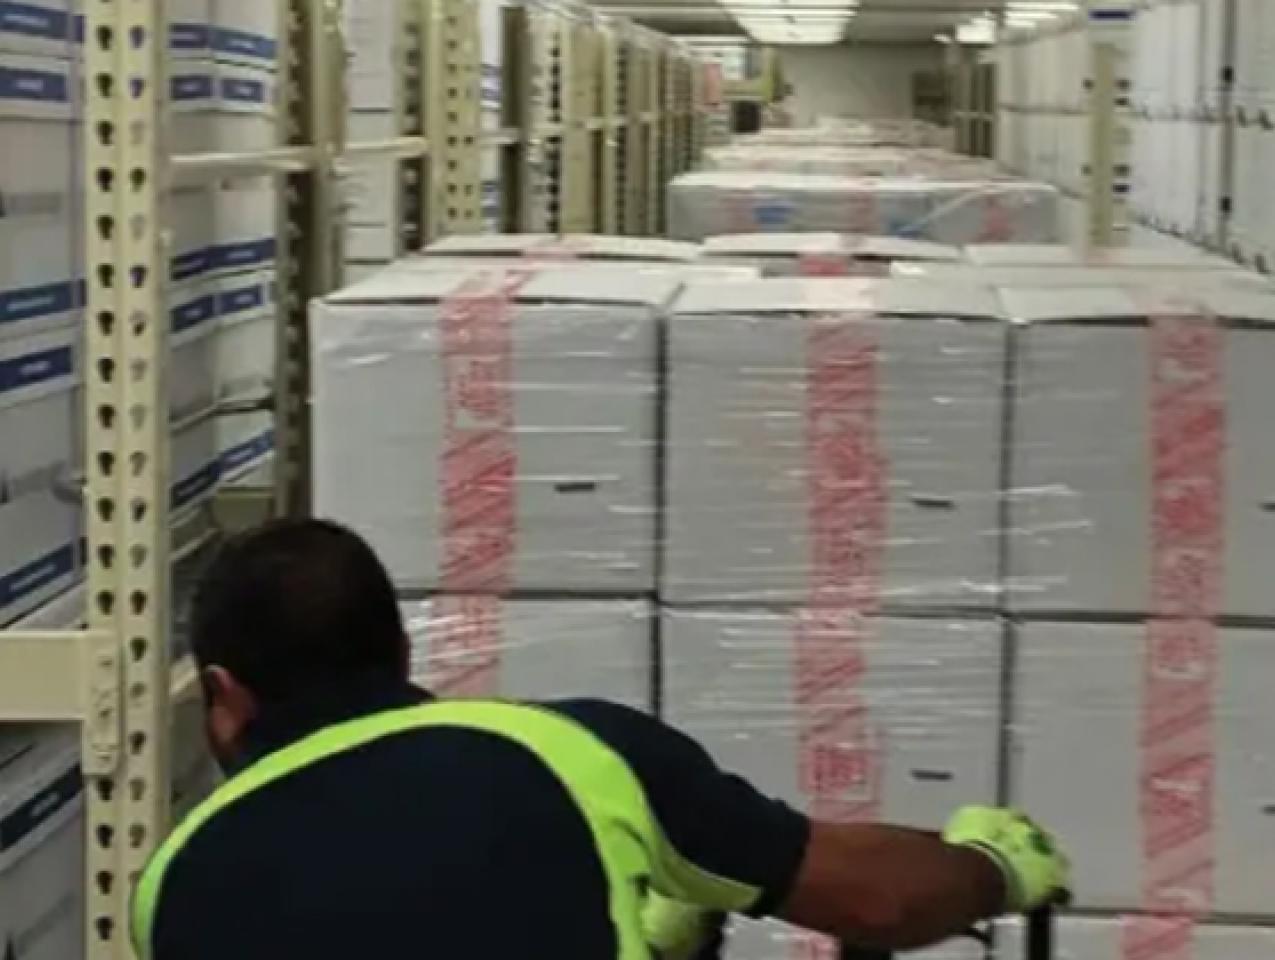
[0,0,704,960]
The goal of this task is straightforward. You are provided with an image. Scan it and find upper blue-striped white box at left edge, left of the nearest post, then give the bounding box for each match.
[0,54,77,339]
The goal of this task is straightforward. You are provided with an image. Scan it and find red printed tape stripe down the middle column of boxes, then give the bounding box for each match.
[792,312,887,960]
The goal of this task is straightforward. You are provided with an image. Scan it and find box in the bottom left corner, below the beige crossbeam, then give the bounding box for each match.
[0,727,85,960]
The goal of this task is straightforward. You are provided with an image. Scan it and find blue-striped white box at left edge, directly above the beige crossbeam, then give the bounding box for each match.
[0,330,80,623]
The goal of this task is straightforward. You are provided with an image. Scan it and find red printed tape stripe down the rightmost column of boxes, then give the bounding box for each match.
[1123,311,1227,960]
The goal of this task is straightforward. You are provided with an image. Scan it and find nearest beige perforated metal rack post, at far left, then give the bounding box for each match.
[84,0,168,960]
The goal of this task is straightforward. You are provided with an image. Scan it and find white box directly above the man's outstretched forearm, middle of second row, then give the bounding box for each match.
[662,608,1003,830]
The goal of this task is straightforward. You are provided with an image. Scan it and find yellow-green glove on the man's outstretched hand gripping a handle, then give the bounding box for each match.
[944,807,1071,913]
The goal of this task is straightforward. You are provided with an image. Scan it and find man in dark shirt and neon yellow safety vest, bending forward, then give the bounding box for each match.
[133,520,1068,960]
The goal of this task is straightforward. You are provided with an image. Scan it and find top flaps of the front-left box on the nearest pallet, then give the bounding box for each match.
[325,264,682,306]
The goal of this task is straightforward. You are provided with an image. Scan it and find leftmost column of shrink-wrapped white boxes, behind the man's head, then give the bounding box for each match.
[311,258,703,709]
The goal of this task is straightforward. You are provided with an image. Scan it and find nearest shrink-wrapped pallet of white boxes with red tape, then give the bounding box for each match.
[312,239,1275,960]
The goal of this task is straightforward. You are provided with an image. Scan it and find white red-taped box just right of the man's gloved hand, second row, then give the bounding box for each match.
[1010,621,1275,915]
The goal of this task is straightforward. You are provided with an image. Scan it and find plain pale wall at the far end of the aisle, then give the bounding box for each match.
[779,43,944,126]
